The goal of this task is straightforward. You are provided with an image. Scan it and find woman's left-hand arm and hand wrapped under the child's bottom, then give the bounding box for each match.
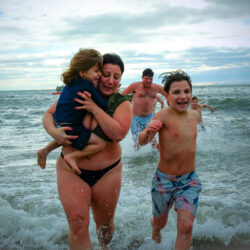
[43,102,78,145]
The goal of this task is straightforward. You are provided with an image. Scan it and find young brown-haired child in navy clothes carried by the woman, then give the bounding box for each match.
[37,49,108,174]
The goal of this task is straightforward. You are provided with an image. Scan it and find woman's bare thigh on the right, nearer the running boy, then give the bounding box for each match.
[92,162,122,224]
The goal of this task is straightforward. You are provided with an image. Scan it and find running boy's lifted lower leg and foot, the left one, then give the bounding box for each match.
[150,214,168,243]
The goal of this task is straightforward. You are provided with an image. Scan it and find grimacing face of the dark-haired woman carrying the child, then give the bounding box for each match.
[98,63,122,96]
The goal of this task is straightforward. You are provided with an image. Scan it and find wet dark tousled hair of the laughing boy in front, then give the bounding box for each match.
[160,69,192,93]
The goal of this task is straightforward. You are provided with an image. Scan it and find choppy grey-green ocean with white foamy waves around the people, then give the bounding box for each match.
[0,84,250,250]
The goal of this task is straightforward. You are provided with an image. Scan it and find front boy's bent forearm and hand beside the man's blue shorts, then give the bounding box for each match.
[138,120,162,145]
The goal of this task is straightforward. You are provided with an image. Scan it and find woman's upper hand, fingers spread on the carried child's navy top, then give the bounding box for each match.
[74,91,100,115]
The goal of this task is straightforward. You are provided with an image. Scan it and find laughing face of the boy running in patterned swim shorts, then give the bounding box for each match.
[168,80,192,112]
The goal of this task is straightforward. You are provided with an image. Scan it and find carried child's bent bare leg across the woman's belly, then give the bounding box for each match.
[64,133,106,174]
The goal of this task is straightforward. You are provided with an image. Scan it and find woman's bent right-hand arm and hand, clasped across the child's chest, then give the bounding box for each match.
[75,92,132,141]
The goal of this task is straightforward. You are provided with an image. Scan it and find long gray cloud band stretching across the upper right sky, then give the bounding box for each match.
[51,1,250,43]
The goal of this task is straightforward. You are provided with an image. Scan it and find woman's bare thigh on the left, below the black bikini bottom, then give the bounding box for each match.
[57,157,91,219]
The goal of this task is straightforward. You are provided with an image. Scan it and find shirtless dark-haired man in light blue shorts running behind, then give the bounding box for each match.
[122,68,166,150]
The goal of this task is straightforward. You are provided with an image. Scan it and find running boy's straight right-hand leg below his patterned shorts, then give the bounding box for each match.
[175,209,194,250]
